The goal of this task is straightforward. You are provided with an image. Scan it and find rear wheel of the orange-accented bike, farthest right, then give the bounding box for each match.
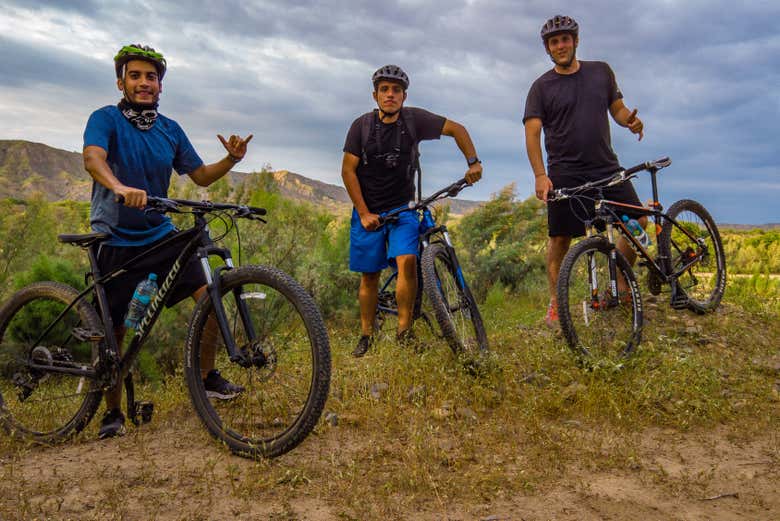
[658,199,726,313]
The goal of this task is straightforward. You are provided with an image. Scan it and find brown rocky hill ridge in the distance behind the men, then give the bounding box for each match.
[0,140,480,215]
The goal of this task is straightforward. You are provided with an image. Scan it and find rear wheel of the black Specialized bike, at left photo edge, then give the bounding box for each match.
[0,282,102,443]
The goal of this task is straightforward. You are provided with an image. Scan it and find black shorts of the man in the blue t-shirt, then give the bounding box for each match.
[98,232,206,328]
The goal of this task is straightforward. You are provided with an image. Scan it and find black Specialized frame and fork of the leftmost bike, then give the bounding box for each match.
[28,207,255,387]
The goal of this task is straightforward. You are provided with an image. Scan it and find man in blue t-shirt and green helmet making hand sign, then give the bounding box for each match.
[84,44,252,438]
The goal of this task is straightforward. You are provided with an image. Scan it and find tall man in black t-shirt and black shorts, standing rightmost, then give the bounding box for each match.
[523,15,647,327]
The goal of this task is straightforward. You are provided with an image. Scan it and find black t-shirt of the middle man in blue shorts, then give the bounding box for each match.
[344,107,447,213]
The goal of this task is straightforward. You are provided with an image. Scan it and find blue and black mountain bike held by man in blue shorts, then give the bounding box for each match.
[376,179,488,354]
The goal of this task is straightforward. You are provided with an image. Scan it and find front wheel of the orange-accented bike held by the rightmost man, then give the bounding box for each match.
[557,237,642,360]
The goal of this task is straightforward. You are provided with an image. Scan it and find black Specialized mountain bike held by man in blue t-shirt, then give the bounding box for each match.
[0,197,330,457]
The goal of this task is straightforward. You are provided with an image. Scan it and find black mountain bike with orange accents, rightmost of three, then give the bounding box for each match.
[548,158,726,357]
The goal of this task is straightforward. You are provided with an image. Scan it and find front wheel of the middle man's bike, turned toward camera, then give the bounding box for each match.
[420,243,488,354]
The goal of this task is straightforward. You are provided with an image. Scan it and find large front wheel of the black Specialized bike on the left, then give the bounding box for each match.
[185,266,330,457]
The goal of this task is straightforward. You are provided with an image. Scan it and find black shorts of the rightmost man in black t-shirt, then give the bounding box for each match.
[547,174,642,237]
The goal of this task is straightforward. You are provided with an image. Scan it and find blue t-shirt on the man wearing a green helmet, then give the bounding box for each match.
[84,105,203,246]
